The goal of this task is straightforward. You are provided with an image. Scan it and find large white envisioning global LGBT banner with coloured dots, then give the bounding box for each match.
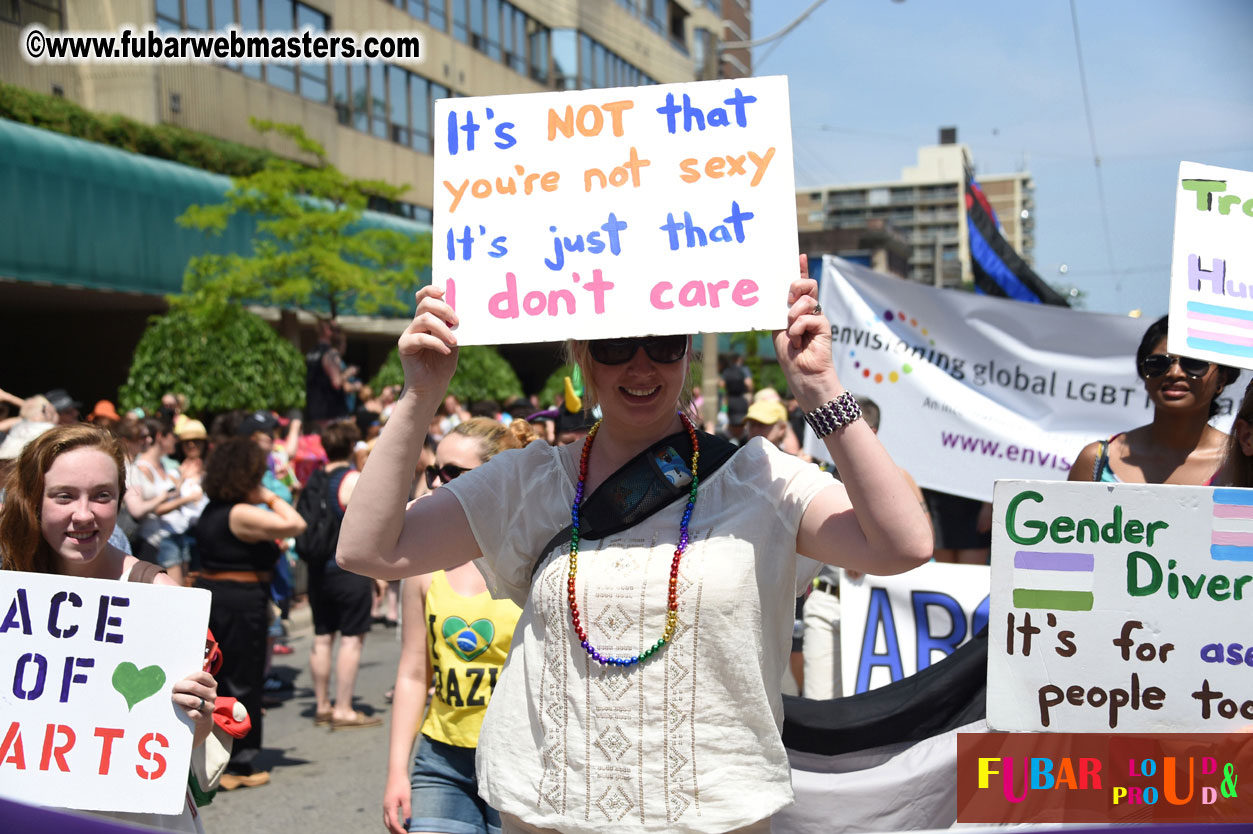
[804,256,1253,501]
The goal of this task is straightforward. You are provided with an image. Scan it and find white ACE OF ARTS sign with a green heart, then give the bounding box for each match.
[0,571,209,814]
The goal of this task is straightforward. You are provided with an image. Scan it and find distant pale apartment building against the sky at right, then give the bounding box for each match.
[797,128,1035,287]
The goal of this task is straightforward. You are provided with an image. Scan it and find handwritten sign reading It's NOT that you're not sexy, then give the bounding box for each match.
[431,76,798,344]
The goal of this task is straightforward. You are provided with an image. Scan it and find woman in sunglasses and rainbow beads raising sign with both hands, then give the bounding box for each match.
[338,257,932,834]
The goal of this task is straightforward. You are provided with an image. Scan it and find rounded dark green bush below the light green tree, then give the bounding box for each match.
[118,306,304,413]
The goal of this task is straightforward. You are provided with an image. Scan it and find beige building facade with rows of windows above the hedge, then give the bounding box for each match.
[0,0,731,220]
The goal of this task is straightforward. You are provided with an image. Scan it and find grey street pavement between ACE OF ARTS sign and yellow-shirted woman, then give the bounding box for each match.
[200,606,400,834]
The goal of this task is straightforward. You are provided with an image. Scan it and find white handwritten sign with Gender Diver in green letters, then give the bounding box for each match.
[987,481,1253,733]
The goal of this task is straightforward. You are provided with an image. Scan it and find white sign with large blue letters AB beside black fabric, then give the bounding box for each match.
[840,562,989,696]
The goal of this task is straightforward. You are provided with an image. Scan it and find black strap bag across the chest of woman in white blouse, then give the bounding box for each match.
[531,432,739,577]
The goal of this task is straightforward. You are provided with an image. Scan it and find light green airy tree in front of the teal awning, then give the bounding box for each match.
[172,119,431,318]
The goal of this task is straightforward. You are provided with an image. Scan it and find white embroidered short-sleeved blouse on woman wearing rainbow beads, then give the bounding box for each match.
[444,440,833,834]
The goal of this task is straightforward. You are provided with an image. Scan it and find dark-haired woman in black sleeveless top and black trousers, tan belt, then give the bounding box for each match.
[195,437,304,790]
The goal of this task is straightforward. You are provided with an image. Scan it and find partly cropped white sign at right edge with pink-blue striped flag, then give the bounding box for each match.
[1167,162,1253,368]
